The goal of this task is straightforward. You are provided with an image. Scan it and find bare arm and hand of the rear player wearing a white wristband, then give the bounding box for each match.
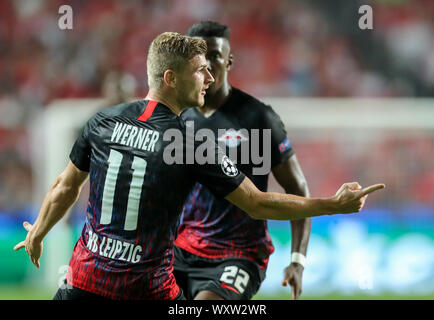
[273,155,311,300]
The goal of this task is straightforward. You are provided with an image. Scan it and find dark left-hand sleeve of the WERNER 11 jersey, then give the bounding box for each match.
[69,115,97,172]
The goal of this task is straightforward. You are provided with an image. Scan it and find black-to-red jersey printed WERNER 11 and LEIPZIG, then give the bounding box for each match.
[67,100,245,299]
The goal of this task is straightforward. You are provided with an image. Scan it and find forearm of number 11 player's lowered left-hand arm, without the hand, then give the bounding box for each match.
[30,178,80,241]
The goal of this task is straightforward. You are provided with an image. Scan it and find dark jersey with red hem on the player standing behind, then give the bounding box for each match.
[175,87,294,269]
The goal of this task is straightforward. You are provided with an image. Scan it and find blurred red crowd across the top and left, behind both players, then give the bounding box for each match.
[0,0,434,215]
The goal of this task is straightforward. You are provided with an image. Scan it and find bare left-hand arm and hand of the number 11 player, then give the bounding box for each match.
[14,161,89,268]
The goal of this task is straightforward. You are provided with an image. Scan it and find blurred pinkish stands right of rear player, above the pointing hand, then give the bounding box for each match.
[282,129,434,214]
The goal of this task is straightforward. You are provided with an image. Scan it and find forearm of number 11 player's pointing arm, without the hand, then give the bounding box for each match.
[254,192,337,220]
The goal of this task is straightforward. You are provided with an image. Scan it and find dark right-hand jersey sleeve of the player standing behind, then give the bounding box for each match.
[264,106,294,168]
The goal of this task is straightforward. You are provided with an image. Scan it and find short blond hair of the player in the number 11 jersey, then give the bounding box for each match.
[146,32,207,89]
